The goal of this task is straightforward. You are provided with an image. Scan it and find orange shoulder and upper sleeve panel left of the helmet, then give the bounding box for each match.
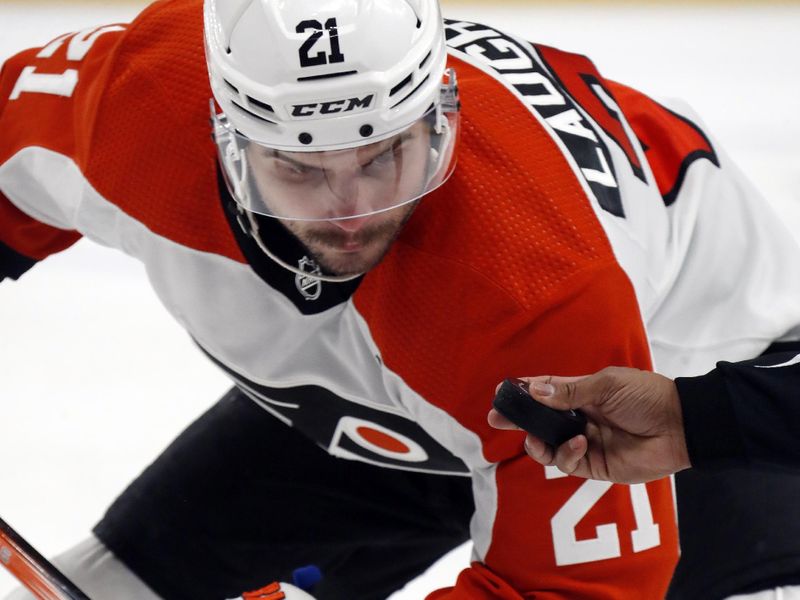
[0,0,243,261]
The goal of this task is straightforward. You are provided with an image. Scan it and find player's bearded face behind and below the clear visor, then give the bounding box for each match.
[248,123,430,275]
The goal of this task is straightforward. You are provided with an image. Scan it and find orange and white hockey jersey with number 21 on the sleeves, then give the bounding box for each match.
[0,0,800,600]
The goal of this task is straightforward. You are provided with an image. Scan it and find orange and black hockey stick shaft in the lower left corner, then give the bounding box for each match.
[0,519,90,600]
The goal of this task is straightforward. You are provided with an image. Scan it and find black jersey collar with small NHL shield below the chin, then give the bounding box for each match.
[217,166,362,315]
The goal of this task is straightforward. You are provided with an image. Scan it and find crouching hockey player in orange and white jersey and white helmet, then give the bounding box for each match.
[0,0,800,600]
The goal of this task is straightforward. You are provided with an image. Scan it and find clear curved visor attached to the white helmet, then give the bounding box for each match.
[213,104,459,221]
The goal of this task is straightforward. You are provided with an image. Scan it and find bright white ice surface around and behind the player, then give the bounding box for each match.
[0,0,800,600]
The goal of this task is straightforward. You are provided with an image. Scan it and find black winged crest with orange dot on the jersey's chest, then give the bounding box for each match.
[200,342,469,475]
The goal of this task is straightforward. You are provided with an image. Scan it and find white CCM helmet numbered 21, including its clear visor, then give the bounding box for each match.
[204,0,458,220]
